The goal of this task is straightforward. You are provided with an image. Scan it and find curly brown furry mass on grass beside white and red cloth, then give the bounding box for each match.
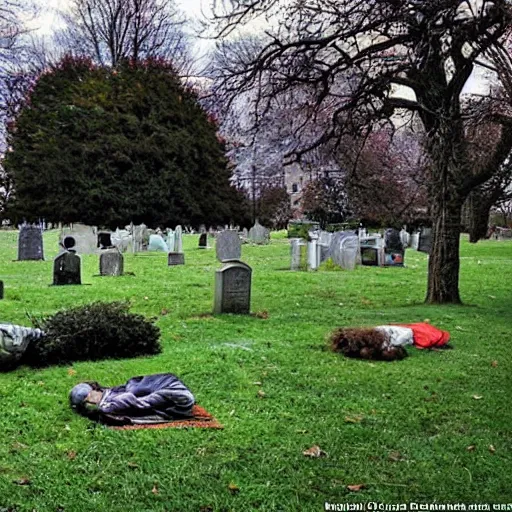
[330,328,407,361]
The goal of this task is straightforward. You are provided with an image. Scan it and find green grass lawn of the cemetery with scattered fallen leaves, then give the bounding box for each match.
[0,231,512,512]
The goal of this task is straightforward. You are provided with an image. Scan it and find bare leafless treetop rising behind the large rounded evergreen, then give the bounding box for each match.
[57,0,191,71]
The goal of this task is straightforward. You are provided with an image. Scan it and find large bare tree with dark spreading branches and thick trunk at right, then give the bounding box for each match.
[208,0,512,303]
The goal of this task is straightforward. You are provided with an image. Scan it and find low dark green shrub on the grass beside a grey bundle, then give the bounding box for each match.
[23,302,162,366]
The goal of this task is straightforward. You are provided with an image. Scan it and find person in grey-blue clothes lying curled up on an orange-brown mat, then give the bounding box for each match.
[69,373,195,425]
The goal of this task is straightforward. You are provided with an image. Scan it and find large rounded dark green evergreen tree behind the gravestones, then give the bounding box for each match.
[5,57,244,227]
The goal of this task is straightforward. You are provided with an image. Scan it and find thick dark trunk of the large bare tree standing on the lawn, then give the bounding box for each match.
[426,173,463,304]
